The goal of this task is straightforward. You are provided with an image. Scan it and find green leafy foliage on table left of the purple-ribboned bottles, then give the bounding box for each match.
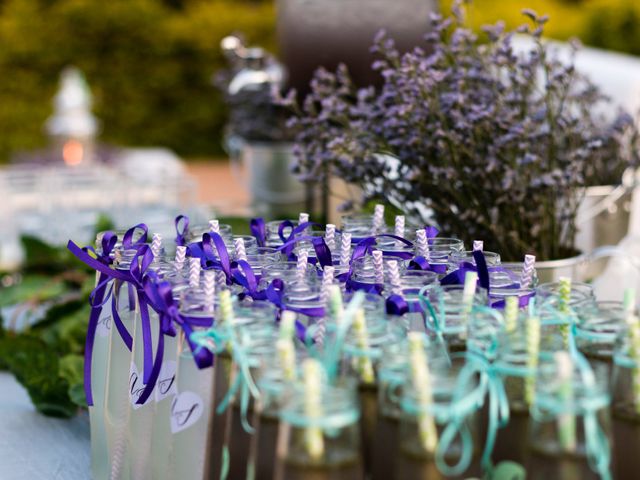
[0,237,95,417]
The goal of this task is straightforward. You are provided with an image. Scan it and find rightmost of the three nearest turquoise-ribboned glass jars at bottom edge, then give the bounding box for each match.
[527,351,611,480]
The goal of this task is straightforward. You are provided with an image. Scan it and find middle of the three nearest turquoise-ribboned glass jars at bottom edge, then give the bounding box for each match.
[397,356,482,480]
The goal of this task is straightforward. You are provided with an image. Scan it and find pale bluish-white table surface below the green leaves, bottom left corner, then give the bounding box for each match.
[0,372,91,480]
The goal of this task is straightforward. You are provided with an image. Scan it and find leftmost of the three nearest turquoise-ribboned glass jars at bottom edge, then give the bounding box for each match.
[275,382,362,480]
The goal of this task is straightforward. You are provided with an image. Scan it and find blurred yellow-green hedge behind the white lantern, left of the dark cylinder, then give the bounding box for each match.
[0,0,275,162]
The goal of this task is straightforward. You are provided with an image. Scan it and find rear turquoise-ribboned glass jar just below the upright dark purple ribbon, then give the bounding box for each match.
[423,285,488,351]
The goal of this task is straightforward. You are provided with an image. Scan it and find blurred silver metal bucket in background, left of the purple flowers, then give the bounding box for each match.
[232,142,306,217]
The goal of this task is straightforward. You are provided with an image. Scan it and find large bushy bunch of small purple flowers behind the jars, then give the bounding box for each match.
[281,3,640,260]
